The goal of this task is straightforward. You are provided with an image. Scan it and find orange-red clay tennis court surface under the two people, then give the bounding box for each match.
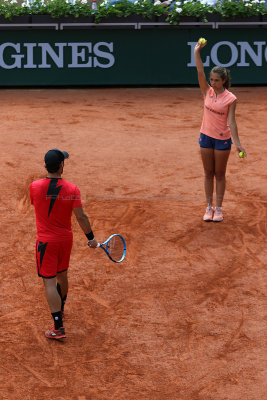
[0,87,267,400]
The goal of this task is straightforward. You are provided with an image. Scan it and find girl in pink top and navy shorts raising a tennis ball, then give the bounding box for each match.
[194,40,245,222]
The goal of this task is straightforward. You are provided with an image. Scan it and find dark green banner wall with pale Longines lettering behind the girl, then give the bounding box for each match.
[0,28,267,86]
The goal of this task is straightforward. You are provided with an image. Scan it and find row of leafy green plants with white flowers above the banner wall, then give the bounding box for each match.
[0,0,267,25]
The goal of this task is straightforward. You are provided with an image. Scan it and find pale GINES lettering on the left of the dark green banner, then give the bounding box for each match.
[0,42,115,69]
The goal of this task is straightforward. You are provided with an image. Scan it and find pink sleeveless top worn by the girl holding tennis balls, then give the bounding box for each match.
[200,87,236,140]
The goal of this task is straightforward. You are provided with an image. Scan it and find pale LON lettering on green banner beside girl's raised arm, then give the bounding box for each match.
[187,41,267,67]
